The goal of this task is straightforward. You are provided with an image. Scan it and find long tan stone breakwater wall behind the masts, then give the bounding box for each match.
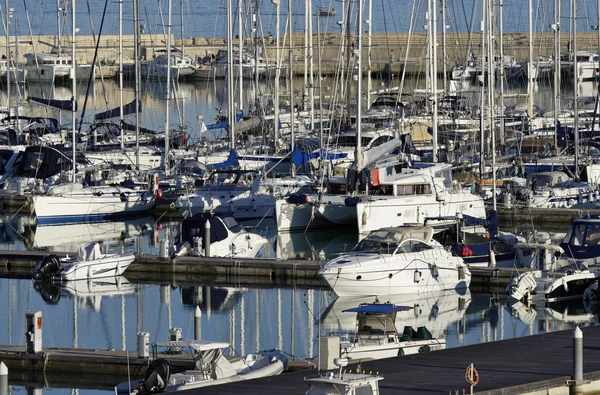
[0,33,598,76]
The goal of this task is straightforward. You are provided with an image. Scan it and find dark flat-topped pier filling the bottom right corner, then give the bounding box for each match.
[179,326,600,395]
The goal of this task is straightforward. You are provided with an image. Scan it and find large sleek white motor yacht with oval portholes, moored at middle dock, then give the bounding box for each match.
[317,226,471,297]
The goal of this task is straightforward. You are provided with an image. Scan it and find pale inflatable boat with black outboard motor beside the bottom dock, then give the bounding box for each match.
[115,340,287,395]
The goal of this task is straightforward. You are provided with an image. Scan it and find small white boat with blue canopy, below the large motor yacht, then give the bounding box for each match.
[340,303,446,360]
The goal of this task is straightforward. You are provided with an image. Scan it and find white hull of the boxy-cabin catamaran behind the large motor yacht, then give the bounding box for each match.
[356,192,486,234]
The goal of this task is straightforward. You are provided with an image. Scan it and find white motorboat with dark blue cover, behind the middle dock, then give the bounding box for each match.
[173,213,268,258]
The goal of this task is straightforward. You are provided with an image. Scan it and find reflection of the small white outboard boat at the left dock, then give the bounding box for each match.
[33,275,135,311]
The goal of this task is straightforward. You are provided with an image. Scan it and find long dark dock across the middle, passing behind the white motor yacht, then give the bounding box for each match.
[0,250,528,292]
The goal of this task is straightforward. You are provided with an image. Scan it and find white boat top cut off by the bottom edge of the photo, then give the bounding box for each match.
[304,358,383,395]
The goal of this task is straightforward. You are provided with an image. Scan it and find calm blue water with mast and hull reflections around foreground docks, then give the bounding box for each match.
[0,216,596,394]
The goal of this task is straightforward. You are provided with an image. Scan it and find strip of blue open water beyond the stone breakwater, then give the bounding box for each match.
[4,0,597,37]
